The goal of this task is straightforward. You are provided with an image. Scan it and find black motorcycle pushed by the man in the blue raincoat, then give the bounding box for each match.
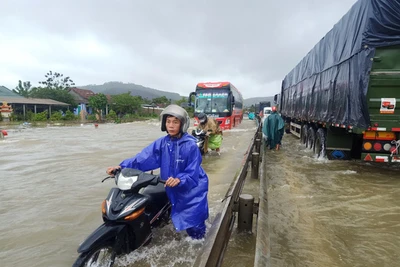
[73,168,171,267]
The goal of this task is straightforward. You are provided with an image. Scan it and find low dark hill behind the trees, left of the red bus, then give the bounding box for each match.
[77,82,182,101]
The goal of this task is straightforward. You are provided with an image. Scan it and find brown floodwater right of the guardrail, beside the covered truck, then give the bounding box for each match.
[265,134,400,267]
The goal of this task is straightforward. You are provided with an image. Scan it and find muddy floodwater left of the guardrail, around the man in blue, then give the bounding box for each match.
[0,120,256,267]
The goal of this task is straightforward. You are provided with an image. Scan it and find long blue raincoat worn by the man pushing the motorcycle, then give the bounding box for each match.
[120,133,208,231]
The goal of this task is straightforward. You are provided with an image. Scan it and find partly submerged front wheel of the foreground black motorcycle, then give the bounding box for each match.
[72,246,116,267]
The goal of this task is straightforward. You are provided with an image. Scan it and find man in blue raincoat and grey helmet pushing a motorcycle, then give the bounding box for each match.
[107,105,208,239]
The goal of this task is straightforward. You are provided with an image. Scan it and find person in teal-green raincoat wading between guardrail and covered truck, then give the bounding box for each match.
[262,106,285,150]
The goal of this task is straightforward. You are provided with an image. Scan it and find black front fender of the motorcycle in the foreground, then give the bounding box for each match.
[78,223,126,253]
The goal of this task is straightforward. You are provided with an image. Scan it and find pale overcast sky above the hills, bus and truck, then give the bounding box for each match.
[0,0,356,98]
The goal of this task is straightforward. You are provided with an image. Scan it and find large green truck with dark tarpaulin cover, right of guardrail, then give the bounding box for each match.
[275,0,400,163]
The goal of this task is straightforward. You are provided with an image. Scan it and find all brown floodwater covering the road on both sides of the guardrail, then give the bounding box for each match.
[0,120,400,267]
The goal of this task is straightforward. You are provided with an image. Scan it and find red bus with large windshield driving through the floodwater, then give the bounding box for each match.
[189,82,243,130]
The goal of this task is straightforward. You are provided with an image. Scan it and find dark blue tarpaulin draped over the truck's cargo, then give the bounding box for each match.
[280,0,400,128]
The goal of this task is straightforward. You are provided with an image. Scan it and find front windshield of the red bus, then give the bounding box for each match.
[195,89,231,113]
